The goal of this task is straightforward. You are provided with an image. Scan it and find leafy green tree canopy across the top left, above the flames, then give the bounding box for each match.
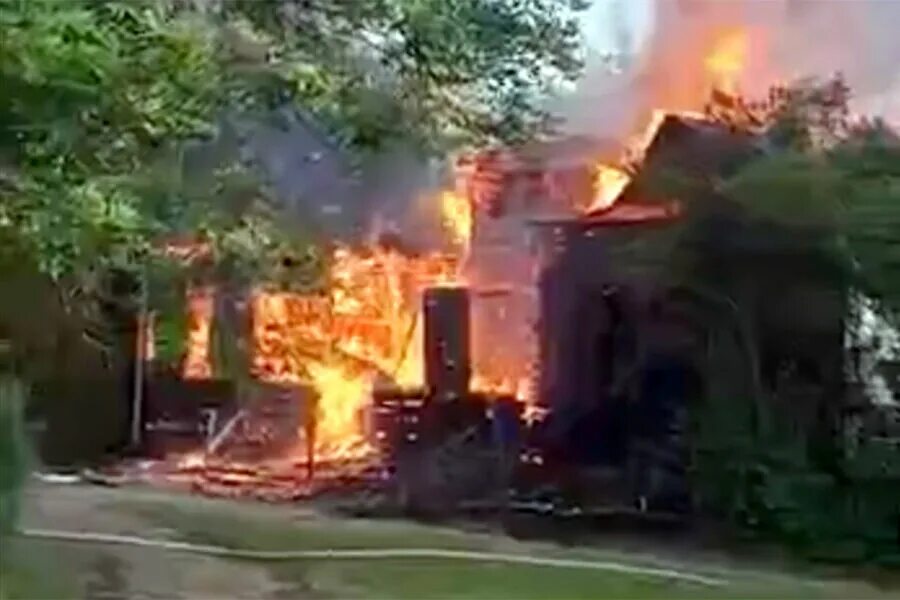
[0,0,580,372]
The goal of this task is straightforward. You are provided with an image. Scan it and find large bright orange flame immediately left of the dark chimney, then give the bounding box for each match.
[253,241,457,457]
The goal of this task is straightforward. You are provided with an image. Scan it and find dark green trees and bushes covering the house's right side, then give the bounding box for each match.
[643,80,900,564]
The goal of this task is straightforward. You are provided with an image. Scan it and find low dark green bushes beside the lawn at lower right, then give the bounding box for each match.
[693,386,900,565]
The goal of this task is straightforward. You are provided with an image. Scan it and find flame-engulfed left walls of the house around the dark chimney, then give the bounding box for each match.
[174,146,589,468]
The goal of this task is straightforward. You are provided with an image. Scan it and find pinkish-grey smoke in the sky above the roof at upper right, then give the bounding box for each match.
[564,0,900,139]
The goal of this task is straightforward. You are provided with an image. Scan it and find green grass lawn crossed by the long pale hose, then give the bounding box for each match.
[107,499,880,599]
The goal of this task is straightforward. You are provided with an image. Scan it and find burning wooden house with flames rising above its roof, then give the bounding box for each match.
[128,7,872,509]
